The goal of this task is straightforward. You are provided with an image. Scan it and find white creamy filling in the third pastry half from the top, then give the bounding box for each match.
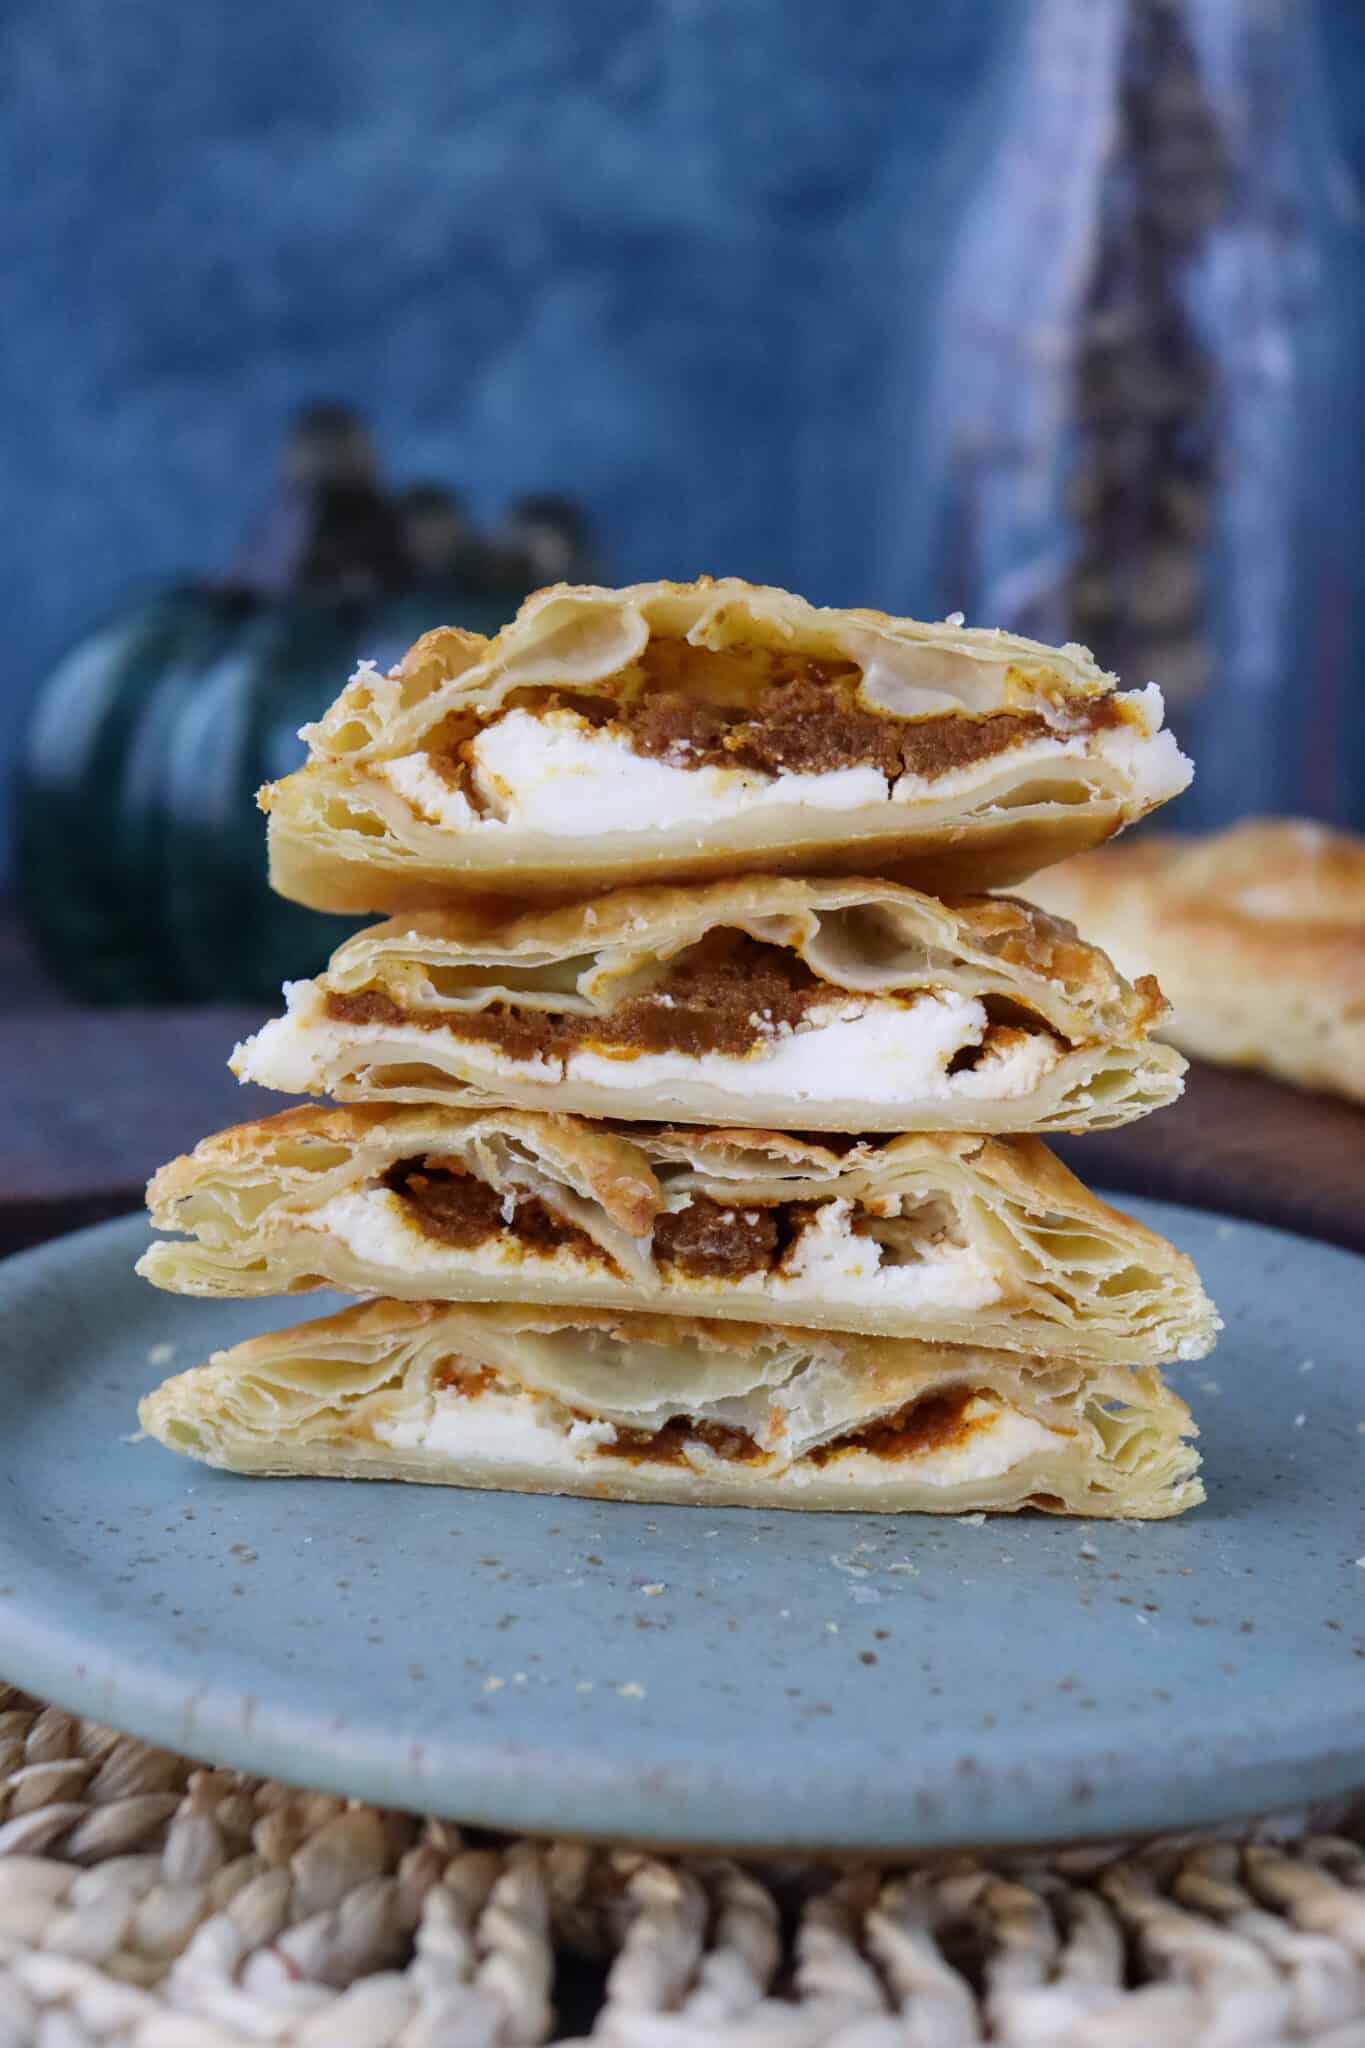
[295,1188,1001,1311]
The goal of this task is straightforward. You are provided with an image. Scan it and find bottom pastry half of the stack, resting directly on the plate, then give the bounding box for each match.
[139,1300,1203,1516]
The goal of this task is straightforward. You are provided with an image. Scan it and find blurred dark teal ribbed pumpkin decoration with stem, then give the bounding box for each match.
[16,408,581,1004]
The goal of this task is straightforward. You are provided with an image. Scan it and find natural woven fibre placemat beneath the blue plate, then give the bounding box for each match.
[0,1686,1365,2048]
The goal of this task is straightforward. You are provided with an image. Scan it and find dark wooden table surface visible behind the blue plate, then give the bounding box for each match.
[0,1010,1365,1253]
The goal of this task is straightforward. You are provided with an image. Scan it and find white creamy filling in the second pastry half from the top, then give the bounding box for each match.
[233,981,1064,1112]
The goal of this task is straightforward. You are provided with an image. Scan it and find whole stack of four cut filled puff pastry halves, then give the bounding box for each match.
[141,580,1216,1516]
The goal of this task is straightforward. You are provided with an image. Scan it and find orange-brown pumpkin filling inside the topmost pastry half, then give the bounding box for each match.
[428,639,1128,801]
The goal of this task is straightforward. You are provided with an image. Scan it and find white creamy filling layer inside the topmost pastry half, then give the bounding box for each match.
[370,684,1193,836]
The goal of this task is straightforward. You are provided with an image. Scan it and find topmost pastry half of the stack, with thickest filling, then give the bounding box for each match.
[262,578,1191,911]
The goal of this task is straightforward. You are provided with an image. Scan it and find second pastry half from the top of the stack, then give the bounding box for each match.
[231,874,1185,1133]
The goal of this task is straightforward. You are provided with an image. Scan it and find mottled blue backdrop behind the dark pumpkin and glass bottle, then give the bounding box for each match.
[0,0,1365,872]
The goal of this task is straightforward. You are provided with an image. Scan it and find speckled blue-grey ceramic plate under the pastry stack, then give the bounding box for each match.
[0,1204,1365,1849]
